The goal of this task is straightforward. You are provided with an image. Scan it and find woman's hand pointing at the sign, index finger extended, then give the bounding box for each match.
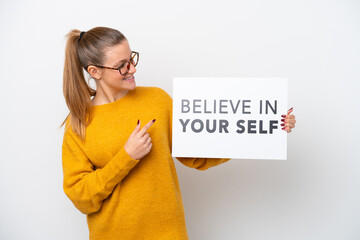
[124,119,155,160]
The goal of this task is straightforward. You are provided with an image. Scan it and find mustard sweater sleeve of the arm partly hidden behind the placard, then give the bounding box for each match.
[160,87,231,171]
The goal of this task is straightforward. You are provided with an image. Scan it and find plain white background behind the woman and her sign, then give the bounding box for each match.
[0,0,360,240]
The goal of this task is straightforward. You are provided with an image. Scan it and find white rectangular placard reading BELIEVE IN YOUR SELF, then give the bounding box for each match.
[172,78,288,160]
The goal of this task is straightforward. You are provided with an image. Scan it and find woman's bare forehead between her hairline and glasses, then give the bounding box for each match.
[105,40,131,64]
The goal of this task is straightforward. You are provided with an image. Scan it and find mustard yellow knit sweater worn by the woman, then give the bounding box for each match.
[62,86,230,240]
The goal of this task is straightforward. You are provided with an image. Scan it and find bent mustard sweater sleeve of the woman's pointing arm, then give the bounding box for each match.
[62,126,139,214]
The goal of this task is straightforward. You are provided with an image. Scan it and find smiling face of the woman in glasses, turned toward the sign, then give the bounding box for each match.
[94,40,136,91]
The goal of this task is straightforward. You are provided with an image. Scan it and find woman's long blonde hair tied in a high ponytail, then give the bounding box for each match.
[60,27,126,141]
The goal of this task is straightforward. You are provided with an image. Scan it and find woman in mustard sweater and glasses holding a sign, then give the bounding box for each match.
[62,27,295,240]
